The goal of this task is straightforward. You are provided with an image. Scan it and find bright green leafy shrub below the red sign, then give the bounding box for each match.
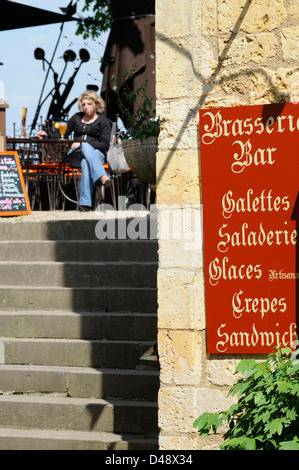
[194,348,299,450]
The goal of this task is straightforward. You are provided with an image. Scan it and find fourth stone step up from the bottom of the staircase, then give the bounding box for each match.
[0,337,157,369]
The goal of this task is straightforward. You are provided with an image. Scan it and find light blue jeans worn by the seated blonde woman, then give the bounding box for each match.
[68,142,107,207]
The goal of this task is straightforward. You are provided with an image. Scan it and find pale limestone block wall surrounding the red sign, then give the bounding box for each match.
[156,0,299,450]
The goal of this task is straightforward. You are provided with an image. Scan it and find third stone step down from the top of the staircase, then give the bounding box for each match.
[0,261,157,288]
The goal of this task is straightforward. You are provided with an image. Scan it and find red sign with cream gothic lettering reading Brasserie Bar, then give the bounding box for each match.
[200,103,299,354]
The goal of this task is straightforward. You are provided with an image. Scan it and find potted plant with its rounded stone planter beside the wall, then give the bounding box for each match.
[112,72,160,184]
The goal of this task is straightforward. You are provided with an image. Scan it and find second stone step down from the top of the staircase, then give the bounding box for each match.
[0,240,158,262]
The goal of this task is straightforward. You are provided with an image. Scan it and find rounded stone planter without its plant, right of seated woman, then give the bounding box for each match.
[122,137,158,184]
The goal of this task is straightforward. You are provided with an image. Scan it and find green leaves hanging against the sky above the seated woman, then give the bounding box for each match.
[76,0,112,39]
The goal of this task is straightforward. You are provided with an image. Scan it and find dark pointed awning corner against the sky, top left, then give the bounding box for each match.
[0,0,78,31]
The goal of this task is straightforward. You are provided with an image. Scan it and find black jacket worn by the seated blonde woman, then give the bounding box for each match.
[64,112,111,153]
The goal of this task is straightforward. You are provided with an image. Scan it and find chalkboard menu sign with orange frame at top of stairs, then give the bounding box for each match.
[0,152,31,216]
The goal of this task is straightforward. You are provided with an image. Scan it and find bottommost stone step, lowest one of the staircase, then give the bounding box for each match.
[0,428,158,451]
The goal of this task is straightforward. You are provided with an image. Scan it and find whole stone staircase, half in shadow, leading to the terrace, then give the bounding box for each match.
[0,214,159,450]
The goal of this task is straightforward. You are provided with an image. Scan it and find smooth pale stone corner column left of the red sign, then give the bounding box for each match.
[156,0,205,450]
